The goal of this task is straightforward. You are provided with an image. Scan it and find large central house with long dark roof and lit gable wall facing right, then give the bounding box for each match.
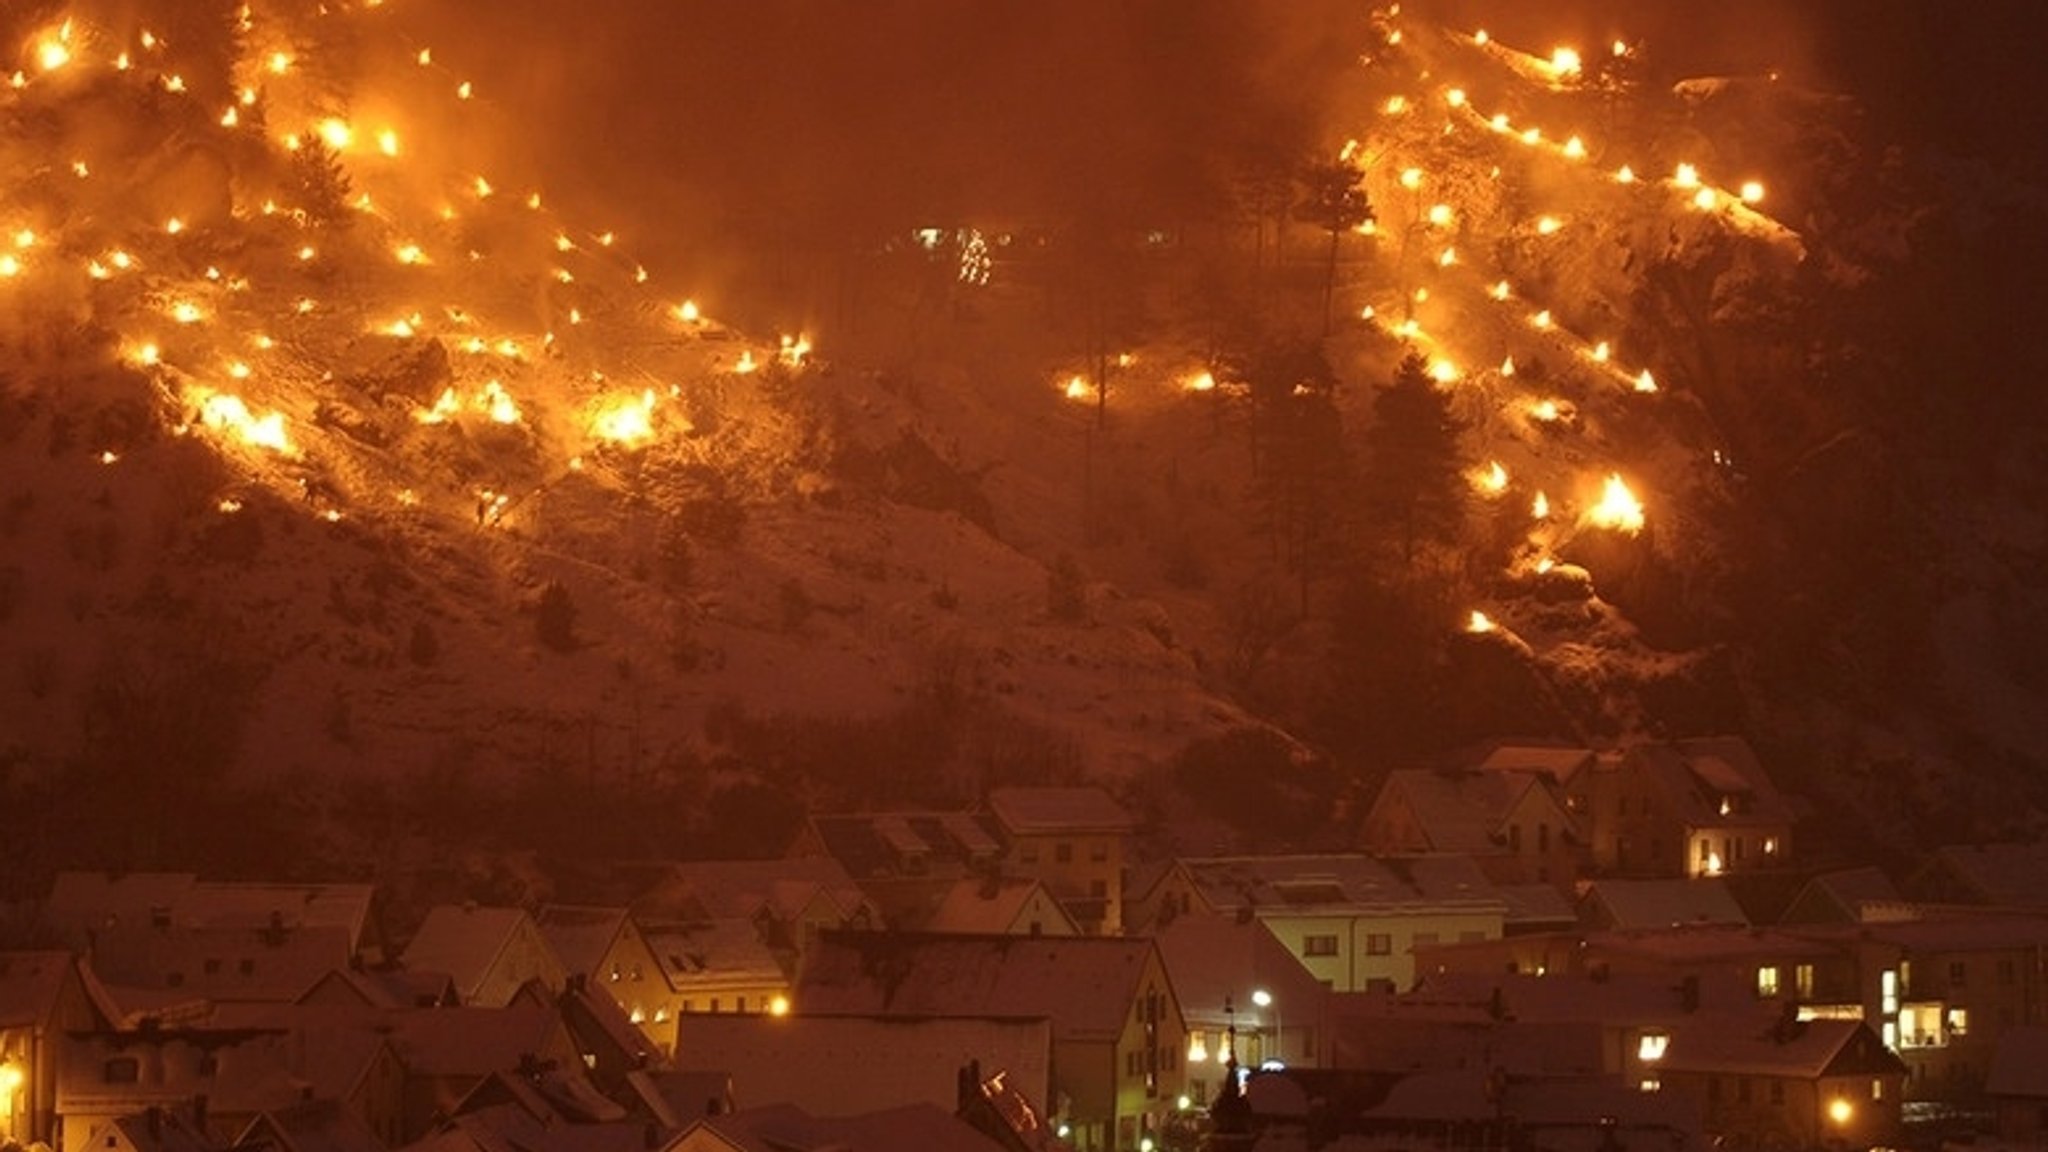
[793,933,1188,1152]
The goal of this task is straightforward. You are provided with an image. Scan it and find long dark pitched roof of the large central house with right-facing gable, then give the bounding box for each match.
[793,933,1155,1039]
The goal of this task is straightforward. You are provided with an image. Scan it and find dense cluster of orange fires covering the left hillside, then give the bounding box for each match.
[0,0,811,532]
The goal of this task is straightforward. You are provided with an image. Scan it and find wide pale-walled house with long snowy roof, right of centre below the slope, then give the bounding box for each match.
[1133,855,1507,992]
